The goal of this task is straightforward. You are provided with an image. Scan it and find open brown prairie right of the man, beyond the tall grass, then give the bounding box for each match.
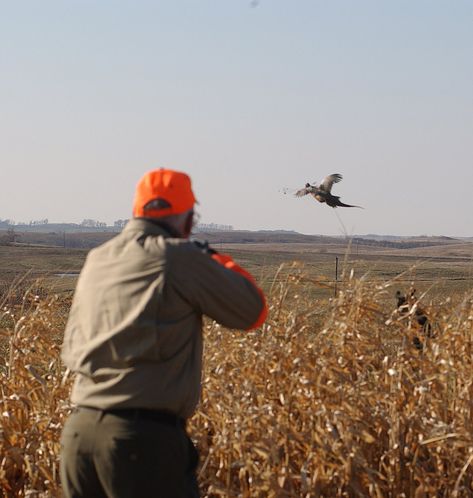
[220,241,473,299]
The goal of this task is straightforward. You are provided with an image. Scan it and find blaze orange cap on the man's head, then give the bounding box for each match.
[133,168,196,218]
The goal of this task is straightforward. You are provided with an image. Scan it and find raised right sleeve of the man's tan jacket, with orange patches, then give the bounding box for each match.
[169,243,268,330]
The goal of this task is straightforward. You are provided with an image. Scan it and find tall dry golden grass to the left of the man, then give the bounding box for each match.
[0,285,70,497]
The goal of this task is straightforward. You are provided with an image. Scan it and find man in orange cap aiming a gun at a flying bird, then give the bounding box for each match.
[61,169,267,498]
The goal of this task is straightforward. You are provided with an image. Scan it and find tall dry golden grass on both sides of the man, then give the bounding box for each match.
[0,269,473,498]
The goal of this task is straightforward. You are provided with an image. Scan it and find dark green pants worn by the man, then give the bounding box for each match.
[61,408,199,498]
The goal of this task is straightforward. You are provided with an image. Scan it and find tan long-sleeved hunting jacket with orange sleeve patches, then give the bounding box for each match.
[62,218,265,418]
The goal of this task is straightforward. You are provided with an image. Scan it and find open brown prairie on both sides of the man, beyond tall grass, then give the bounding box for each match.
[0,232,473,299]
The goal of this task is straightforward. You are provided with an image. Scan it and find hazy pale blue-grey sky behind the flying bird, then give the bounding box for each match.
[0,0,473,236]
